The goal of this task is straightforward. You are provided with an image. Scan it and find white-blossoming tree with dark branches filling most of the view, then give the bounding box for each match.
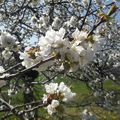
[0,0,120,120]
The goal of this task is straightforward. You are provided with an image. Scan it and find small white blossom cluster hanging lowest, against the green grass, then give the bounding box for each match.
[42,82,76,115]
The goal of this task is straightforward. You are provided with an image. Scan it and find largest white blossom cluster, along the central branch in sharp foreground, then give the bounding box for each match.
[20,28,101,72]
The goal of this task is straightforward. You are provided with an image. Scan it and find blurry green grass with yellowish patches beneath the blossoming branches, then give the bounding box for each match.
[0,76,120,120]
